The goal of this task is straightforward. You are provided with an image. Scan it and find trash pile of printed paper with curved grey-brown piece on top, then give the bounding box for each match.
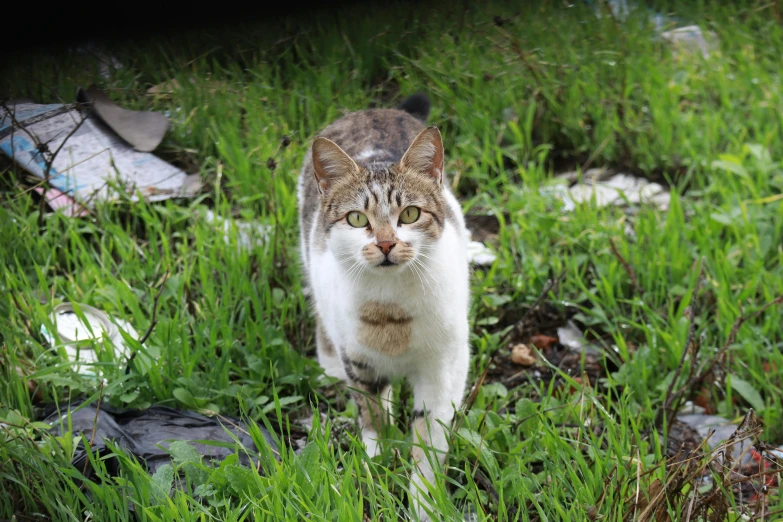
[0,86,201,216]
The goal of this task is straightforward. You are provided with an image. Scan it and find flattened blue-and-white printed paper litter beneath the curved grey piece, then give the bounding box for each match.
[0,96,201,208]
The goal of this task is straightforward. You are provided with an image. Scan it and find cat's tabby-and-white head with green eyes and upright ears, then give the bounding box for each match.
[313,127,449,272]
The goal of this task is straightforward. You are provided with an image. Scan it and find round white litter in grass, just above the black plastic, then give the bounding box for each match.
[41,303,139,376]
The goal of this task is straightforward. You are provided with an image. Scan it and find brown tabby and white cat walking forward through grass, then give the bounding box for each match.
[298,94,470,520]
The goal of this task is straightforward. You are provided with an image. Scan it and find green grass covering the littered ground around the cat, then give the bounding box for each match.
[0,1,783,521]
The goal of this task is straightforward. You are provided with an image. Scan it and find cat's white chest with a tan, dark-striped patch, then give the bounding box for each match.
[311,219,468,376]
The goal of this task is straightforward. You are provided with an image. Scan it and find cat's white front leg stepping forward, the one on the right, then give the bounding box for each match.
[409,351,468,521]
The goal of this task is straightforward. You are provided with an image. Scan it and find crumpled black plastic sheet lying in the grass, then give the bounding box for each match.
[43,403,279,482]
